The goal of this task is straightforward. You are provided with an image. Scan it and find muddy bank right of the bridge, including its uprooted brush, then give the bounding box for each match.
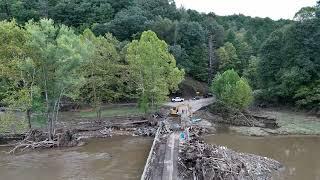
[195,102,320,136]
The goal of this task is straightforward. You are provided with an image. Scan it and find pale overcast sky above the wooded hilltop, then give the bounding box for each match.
[175,0,317,19]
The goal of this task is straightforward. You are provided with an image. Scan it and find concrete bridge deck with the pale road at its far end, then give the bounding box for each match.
[141,98,214,180]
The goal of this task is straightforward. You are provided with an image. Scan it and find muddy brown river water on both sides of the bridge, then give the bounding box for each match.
[0,134,320,180]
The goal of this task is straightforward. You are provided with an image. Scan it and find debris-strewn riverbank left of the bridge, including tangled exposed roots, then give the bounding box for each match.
[0,113,157,154]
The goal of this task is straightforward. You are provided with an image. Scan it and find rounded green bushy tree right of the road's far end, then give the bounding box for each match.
[211,69,253,110]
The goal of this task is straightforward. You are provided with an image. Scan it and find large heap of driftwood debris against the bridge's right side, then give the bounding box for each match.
[178,138,282,180]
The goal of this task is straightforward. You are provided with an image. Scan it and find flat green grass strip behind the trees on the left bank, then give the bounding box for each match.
[80,107,143,118]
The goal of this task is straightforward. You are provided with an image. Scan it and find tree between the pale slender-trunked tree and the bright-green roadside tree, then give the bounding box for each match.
[81,29,127,120]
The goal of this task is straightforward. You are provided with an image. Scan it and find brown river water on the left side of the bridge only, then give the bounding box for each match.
[0,137,152,180]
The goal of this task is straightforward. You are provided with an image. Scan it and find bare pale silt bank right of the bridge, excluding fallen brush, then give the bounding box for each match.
[194,108,320,136]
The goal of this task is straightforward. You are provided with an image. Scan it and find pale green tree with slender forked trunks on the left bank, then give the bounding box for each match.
[25,19,89,140]
